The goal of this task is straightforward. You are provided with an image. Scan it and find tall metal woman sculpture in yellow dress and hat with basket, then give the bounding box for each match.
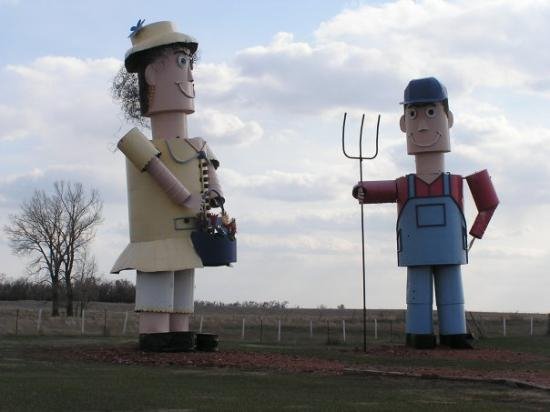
[111,21,236,351]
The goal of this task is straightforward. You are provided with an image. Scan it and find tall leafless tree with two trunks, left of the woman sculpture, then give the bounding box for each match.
[4,181,103,316]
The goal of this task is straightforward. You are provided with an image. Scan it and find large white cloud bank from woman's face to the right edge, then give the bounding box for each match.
[198,0,550,115]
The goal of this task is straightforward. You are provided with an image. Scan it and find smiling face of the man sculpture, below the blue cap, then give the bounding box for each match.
[400,102,453,154]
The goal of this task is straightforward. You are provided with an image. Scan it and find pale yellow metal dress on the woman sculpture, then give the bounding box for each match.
[111,134,216,273]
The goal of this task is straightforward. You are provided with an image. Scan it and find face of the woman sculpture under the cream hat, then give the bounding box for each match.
[145,47,195,116]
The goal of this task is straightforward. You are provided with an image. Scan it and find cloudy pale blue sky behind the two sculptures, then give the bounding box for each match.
[0,0,550,313]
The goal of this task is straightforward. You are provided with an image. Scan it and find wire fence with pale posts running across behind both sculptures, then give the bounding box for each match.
[0,308,550,346]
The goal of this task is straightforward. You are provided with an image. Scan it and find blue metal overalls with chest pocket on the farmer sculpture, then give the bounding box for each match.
[397,173,468,335]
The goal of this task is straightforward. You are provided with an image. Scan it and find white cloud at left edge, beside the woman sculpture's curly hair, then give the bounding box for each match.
[0,56,120,150]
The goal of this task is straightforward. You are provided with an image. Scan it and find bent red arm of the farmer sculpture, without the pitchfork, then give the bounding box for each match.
[466,169,499,239]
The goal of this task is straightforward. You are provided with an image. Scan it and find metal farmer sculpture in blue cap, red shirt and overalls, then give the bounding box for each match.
[353,77,499,348]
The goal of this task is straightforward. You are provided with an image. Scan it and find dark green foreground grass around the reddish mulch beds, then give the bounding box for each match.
[0,336,550,411]
